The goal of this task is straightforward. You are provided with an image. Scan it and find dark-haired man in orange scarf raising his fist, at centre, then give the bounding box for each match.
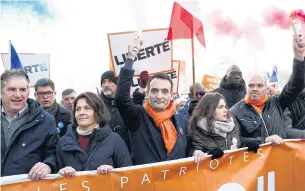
[115,38,205,165]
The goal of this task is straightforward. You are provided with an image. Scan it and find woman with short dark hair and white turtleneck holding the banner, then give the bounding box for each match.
[56,92,132,178]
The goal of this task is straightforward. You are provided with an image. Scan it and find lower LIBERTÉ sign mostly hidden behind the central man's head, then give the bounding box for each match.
[130,60,181,95]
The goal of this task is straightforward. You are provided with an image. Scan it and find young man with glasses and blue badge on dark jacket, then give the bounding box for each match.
[34,78,71,137]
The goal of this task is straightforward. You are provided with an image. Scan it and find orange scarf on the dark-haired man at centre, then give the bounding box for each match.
[143,101,177,155]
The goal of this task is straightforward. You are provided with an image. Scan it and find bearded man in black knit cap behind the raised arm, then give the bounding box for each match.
[100,70,130,149]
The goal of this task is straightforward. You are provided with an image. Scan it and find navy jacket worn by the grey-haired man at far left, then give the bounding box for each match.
[1,99,59,176]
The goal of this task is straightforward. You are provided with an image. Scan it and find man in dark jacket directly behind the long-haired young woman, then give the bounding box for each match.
[212,65,246,108]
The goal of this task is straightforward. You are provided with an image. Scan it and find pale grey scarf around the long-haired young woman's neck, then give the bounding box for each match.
[197,118,235,138]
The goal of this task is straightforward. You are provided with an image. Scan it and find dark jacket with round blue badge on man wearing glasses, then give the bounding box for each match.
[54,103,72,137]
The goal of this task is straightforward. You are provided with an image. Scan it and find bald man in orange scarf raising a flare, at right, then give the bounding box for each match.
[230,31,305,145]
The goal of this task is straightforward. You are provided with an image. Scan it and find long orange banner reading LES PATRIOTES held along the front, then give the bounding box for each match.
[1,140,305,191]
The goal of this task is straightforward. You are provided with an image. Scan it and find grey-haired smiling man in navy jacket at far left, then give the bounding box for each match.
[1,70,59,180]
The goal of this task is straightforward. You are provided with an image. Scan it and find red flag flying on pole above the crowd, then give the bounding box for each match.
[167,2,205,47]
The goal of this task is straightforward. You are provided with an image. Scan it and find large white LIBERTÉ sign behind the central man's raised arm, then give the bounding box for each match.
[108,29,173,76]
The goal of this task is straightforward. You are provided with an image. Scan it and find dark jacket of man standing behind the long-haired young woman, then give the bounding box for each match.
[212,76,247,108]
